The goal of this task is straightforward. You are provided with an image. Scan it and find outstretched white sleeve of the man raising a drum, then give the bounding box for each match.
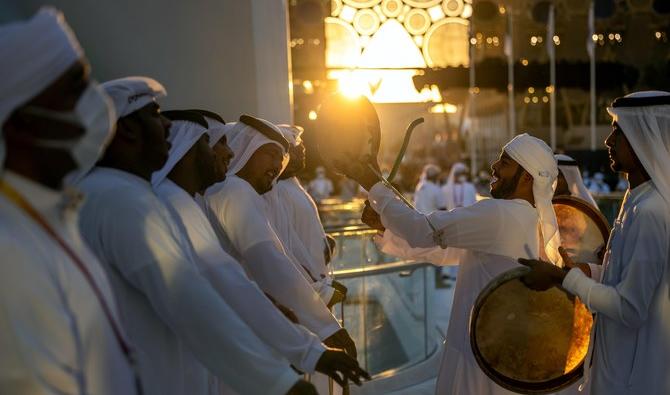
[369,183,502,257]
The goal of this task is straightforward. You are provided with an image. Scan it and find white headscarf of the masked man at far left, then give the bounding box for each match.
[0,7,84,166]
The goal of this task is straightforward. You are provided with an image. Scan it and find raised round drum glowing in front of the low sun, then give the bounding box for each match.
[315,94,381,172]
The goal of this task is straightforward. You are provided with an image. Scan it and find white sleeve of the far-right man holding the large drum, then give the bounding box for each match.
[563,212,668,328]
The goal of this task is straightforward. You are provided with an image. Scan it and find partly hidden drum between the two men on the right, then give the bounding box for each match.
[552,196,610,263]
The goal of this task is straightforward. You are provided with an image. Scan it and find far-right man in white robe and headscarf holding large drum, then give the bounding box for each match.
[522,91,670,395]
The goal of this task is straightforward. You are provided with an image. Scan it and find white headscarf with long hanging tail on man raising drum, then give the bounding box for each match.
[503,133,563,266]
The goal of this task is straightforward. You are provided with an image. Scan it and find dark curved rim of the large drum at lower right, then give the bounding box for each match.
[469,267,586,394]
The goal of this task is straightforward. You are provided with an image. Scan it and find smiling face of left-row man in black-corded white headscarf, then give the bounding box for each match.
[237,143,284,195]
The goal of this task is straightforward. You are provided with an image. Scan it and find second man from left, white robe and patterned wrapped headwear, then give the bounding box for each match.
[79,77,308,395]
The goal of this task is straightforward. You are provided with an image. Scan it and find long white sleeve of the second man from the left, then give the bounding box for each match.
[94,205,299,394]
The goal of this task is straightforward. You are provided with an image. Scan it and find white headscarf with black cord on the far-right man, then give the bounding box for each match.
[607,91,670,207]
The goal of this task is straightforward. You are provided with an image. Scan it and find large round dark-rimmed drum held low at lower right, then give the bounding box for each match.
[470,267,593,394]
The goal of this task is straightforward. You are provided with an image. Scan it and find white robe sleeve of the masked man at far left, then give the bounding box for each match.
[0,241,89,395]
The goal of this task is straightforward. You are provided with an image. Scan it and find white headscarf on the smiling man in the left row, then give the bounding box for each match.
[224,121,289,175]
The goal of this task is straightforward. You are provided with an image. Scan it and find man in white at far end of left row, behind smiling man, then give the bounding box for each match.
[263,125,345,306]
